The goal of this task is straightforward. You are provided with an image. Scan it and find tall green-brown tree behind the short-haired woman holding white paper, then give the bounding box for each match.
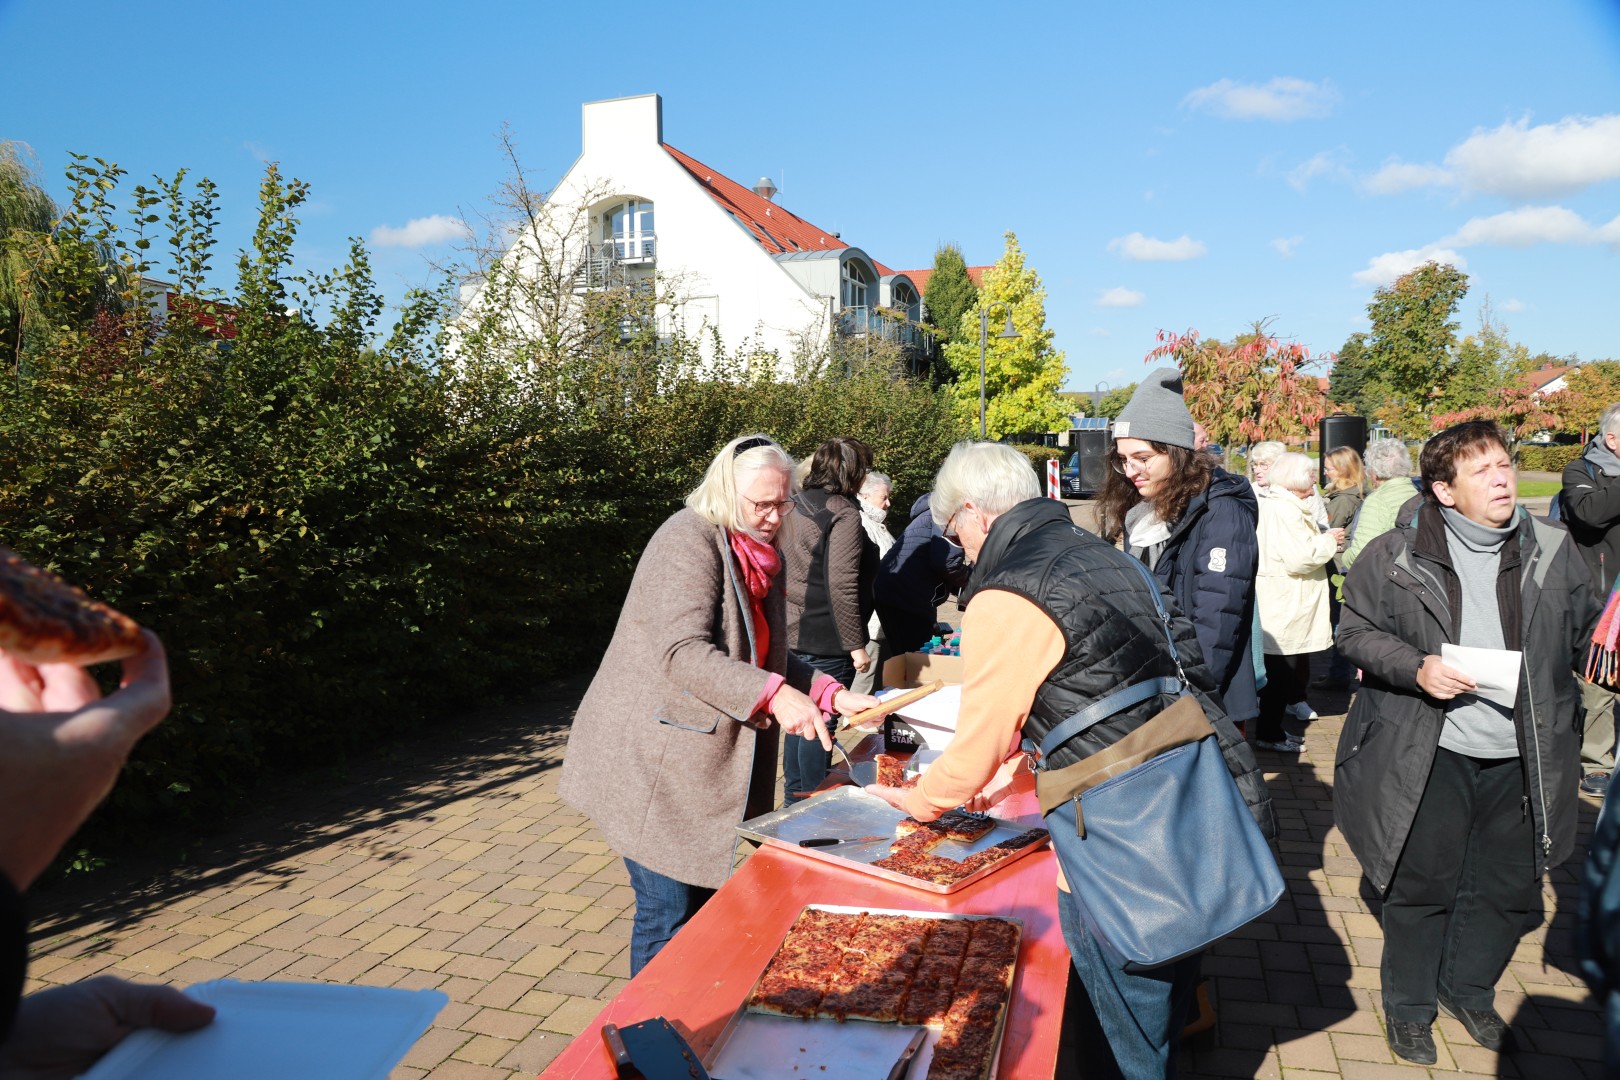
[1367,262,1468,437]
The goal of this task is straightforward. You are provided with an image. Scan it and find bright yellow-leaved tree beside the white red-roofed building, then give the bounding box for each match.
[930,232,1069,439]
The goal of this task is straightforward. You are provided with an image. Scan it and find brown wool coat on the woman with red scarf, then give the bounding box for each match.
[557,510,815,889]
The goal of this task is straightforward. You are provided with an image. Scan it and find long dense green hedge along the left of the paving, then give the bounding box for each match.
[0,160,967,837]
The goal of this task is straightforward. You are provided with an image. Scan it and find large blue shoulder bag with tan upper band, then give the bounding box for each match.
[1035,559,1285,970]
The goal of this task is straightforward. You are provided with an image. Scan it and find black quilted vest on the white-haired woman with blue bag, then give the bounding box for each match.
[969,499,1277,837]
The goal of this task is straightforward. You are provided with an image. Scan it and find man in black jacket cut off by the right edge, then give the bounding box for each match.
[1562,405,1620,798]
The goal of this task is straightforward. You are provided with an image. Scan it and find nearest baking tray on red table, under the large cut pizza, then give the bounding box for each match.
[703,904,1024,1080]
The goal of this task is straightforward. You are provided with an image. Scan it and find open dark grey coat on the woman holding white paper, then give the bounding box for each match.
[1333,505,1601,894]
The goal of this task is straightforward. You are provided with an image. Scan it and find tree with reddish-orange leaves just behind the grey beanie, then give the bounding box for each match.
[1145,322,1327,452]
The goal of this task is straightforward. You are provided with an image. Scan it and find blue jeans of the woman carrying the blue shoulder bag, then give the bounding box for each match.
[1058,889,1204,1080]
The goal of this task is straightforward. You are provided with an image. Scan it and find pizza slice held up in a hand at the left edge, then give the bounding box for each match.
[0,547,146,667]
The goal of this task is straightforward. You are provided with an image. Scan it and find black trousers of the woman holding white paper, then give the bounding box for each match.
[1382,746,1541,1023]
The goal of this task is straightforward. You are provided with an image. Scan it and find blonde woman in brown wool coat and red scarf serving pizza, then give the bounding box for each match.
[559,436,876,975]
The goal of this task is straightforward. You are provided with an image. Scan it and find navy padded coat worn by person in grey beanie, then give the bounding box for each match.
[1132,468,1260,722]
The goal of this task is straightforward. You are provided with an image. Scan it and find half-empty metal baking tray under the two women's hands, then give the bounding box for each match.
[737,787,1050,894]
